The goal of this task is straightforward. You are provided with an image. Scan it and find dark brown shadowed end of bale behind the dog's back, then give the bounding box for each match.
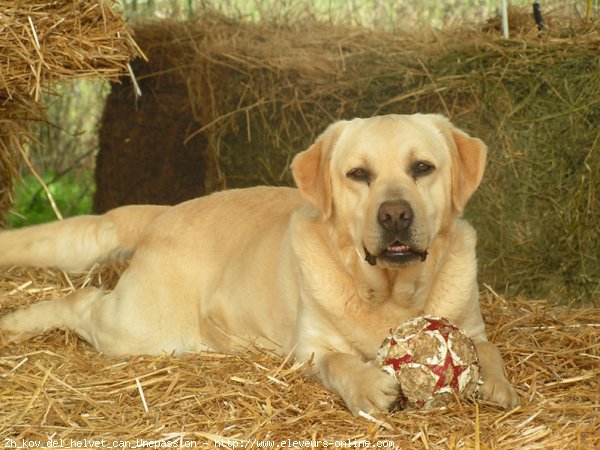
[93,84,206,213]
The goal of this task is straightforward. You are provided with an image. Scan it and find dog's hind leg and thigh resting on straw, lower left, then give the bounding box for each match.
[0,264,208,355]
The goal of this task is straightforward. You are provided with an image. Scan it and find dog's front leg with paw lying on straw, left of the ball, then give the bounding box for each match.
[315,352,399,415]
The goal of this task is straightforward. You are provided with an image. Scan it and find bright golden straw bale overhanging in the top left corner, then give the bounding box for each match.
[0,0,140,101]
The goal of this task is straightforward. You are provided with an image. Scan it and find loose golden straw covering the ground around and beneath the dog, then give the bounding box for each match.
[0,266,600,450]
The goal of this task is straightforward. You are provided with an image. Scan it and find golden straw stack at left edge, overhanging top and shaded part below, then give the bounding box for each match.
[0,0,140,223]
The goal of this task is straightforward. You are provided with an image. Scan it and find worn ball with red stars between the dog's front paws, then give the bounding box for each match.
[376,316,480,409]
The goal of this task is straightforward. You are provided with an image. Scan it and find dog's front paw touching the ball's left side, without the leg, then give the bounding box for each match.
[342,365,400,415]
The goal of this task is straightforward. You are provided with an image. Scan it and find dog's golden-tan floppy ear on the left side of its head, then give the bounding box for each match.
[292,121,345,219]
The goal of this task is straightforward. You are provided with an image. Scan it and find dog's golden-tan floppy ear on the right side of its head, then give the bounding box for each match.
[435,115,487,213]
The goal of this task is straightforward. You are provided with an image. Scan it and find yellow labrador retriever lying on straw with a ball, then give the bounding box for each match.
[0,114,518,414]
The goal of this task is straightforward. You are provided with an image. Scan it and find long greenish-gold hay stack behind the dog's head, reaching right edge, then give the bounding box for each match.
[98,14,600,299]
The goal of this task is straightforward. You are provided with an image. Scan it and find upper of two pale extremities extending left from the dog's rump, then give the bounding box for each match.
[0,205,169,271]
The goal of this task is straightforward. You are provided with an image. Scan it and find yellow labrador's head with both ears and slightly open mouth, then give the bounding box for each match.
[292,114,486,268]
